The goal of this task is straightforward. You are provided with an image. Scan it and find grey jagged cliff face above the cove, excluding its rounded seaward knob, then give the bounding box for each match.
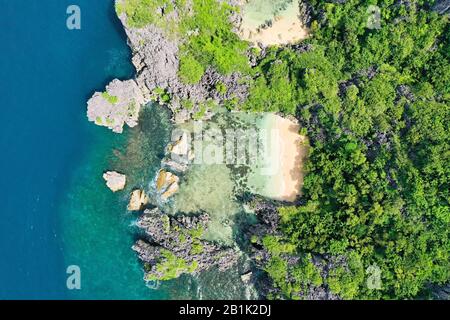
[116,0,249,123]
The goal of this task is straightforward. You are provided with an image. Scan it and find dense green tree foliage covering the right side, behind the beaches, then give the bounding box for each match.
[256,0,450,299]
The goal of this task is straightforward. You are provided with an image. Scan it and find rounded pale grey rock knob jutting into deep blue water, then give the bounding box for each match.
[87,79,146,133]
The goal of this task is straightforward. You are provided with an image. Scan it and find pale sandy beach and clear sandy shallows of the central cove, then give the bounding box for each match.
[170,113,307,244]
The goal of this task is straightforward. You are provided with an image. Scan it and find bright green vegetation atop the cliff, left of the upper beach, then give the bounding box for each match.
[116,0,249,84]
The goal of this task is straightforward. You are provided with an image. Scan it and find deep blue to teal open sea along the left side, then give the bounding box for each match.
[0,0,163,299]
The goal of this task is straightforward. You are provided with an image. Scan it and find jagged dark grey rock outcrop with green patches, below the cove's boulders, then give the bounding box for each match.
[133,208,239,280]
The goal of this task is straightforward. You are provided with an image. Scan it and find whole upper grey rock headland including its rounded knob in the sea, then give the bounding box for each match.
[88,0,251,126]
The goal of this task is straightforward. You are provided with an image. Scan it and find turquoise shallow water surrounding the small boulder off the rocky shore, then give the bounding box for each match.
[60,106,170,299]
